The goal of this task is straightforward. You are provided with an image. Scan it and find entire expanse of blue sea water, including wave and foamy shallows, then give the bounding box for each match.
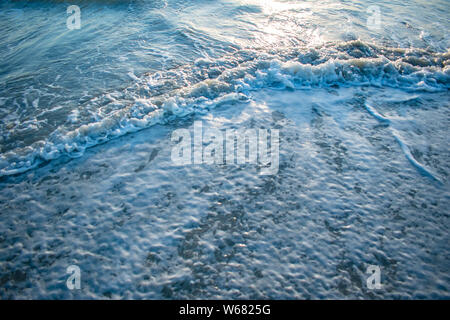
[0,0,450,298]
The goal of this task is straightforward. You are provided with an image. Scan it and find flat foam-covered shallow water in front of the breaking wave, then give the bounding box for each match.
[0,87,450,299]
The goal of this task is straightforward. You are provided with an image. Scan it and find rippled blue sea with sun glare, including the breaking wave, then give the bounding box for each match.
[0,1,449,175]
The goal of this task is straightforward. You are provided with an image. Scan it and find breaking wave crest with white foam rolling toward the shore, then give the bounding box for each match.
[0,40,450,176]
